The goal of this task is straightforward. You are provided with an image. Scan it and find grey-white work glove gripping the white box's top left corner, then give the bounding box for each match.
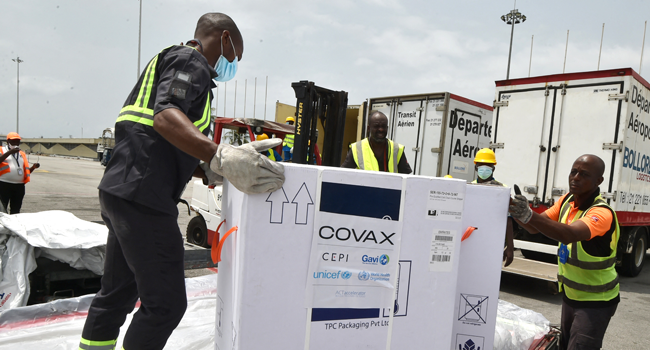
[210,138,284,194]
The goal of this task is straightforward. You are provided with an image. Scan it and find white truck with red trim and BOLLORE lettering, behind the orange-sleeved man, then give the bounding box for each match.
[490,68,650,280]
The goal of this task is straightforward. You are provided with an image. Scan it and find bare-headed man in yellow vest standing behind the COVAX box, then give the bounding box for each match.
[341,112,411,174]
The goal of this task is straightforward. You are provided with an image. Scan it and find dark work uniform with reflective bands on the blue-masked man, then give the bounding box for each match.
[80,46,216,350]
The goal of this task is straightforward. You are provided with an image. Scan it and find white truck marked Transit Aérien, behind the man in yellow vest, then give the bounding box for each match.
[362,92,493,182]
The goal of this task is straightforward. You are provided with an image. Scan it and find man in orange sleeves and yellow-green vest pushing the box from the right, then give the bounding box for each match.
[510,154,620,349]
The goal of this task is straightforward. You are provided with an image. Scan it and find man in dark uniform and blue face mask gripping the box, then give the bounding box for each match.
[79,13,284,350]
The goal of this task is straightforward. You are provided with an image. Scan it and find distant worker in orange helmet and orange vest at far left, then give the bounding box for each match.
[0,132,41,214]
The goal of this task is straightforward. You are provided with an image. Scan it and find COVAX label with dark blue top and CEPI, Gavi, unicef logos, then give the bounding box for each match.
[306,170,403,308]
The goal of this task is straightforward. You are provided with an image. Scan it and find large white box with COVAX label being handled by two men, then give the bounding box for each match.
[216,165,507,350]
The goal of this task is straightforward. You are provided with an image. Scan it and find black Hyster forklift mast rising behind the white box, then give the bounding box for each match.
[291,80,348,167]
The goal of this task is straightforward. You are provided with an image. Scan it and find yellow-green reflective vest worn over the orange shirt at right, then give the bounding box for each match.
[558,195,620,301]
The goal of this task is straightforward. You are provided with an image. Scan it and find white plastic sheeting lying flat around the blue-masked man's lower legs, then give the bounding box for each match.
[0,274,217,350]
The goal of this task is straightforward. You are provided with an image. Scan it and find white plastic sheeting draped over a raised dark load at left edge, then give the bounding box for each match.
[0,210,108,312]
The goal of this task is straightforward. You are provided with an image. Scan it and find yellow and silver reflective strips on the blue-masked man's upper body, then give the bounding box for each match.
[115,46,211,132]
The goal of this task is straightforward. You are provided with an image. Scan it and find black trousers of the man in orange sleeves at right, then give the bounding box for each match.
[560,302,618,350]
